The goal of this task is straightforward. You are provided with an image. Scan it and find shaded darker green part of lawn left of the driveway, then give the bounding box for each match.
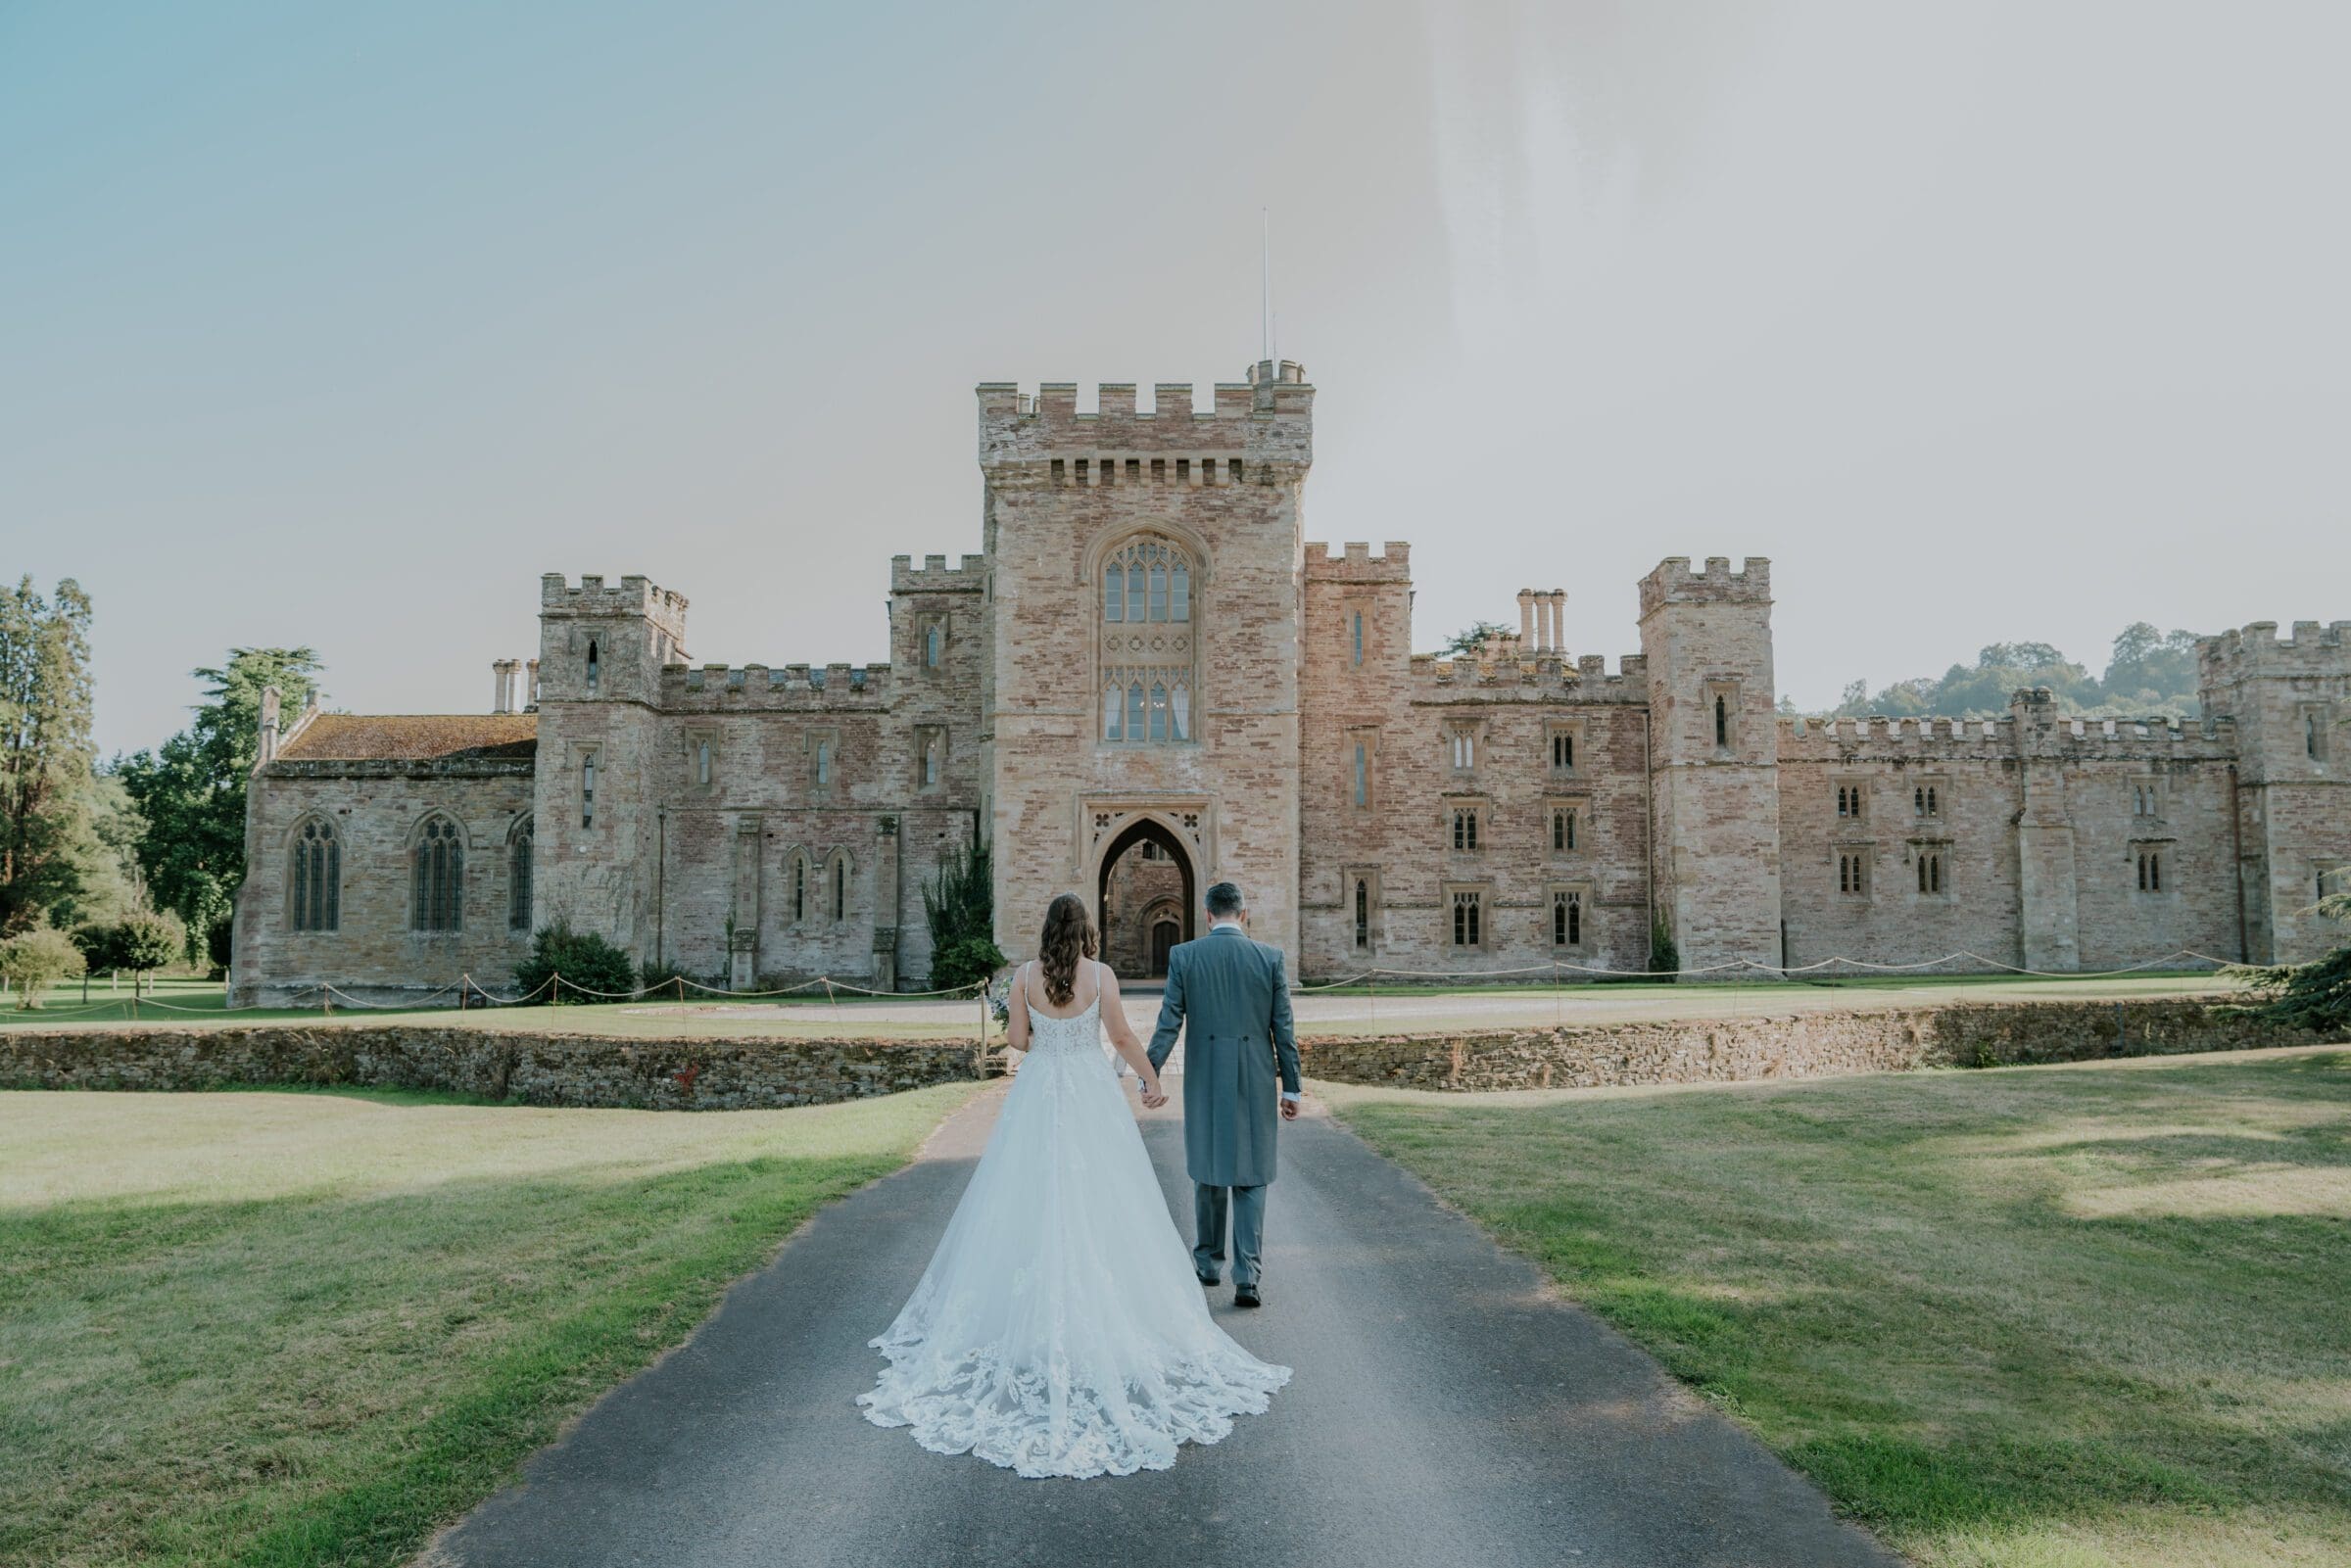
[0,1147,903,1568]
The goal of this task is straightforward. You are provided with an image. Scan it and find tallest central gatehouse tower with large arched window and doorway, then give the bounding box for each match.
[978,359,1315,962]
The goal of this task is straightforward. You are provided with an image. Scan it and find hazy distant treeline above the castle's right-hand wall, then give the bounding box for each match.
[1814,621,2198,719]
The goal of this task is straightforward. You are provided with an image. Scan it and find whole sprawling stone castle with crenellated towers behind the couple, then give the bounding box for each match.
[230,362,2351,1006]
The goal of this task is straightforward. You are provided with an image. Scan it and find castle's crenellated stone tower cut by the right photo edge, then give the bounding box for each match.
[2196,621,2351,964]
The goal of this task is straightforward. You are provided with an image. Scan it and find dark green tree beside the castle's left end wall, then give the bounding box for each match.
[120,648,324,957]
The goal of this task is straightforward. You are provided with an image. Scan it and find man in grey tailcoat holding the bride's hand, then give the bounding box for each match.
[1152,881,1298,1307]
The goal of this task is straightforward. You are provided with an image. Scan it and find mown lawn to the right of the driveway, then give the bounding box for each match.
[1323,1049,2351,1568]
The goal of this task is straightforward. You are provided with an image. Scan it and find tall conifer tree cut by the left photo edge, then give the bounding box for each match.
[0,576,94,935]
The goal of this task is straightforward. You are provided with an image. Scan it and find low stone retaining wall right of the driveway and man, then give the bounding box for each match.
[1298,999,2321,1091]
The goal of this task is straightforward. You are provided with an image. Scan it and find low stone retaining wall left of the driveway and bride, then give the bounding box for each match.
[0,1025,974,1110]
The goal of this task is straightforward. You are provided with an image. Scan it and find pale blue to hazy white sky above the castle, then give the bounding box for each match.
[14,0,2351,750]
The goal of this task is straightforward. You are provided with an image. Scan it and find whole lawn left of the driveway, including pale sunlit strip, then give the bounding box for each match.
[0,1086,971,1568]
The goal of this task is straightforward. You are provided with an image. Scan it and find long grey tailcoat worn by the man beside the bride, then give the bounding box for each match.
[1152,927,1298,1187]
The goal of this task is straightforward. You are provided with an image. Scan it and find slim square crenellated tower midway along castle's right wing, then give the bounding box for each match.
[1641,554,1780,978]
